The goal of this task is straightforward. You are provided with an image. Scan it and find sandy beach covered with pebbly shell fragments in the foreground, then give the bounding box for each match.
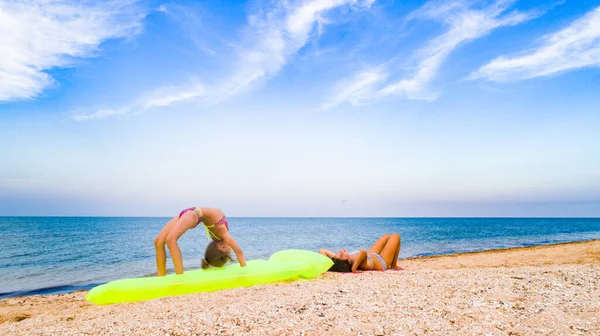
[0,240,600,335]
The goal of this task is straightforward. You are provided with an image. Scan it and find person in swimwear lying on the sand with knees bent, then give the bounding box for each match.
[319,233,402,272]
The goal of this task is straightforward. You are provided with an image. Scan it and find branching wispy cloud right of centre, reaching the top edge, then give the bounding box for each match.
[323,0,539,108]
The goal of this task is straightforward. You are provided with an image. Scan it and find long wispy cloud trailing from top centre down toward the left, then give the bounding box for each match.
[73,0,375,120]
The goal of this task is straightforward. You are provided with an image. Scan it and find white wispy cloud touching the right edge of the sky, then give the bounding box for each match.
[470,7,600,82]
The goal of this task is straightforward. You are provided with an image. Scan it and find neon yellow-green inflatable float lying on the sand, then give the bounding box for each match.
[85,250,333,305]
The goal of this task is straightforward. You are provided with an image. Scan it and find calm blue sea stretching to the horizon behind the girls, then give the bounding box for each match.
[0,217,600,298]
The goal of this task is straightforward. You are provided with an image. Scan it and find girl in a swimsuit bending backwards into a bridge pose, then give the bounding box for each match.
[154,208,246,276]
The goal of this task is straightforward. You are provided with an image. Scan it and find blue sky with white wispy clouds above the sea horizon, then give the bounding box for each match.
[0,0,600,217]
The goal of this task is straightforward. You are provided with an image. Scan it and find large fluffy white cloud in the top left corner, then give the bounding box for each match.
[0,0,145,101]
